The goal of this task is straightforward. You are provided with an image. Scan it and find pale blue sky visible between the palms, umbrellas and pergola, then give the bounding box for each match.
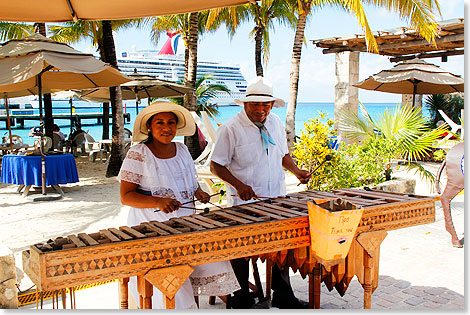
[72,0,467,103]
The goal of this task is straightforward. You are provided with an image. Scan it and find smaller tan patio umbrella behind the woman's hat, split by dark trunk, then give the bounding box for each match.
[75,72,192,114]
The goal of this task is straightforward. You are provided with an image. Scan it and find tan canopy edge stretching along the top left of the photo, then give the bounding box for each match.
[0,0,249,22]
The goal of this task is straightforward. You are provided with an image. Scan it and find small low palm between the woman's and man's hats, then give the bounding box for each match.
[169,74,230,118]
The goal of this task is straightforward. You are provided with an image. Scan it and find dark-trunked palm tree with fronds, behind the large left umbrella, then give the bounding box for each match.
[51,19,141,177]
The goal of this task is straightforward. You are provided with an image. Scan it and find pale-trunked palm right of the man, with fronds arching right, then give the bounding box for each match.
[286,0,440,148]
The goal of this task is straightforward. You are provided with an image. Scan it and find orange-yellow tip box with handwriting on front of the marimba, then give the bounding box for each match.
[308,199,363,265]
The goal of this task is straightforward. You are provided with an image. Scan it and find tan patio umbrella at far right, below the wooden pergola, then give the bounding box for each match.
[353,58,464,106]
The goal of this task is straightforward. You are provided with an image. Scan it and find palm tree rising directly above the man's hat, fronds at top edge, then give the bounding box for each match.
[207,0,296,76]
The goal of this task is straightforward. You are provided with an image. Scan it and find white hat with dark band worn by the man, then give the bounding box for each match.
[233,76,286,107]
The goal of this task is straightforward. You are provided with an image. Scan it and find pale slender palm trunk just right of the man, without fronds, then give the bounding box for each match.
[286,13,307,151]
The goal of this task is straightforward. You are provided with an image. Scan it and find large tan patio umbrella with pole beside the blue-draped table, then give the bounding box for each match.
[0,34,130,198]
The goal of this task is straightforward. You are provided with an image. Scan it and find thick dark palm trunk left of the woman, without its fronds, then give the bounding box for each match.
[102,21,124,177]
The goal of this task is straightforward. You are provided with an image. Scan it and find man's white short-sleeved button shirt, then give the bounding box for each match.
[211,109,289,206]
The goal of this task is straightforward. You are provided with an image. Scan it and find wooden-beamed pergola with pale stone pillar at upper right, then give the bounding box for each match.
[312,18,464,143]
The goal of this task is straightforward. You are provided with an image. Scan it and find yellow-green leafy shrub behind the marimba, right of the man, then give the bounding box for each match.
[293,113,399,190]
